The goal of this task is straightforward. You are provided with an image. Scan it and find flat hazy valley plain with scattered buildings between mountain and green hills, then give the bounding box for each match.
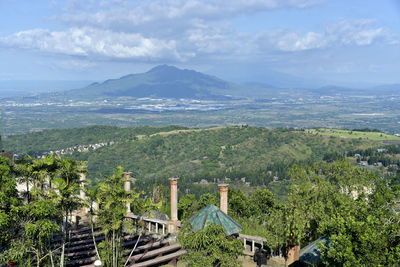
[0,86,400,135]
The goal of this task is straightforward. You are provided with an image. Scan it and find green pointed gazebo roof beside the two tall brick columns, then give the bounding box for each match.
[189,205,243,235]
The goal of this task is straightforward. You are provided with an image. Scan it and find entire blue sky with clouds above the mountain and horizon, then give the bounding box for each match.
[0,0,400,86]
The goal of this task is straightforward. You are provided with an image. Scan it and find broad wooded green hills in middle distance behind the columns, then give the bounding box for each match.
[4,126,379,191]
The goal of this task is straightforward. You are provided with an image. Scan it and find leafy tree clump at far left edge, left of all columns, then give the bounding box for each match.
[0,156,82,266]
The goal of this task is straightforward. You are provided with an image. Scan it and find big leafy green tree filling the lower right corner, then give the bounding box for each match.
[285,161,400,266]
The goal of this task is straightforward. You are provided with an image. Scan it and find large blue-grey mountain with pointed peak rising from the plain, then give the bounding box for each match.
[64,65,234,99]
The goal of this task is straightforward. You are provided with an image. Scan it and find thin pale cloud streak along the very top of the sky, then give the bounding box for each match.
[62,0,324,27]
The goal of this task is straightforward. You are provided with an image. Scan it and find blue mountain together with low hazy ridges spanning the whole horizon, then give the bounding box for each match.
[4,65,400,101]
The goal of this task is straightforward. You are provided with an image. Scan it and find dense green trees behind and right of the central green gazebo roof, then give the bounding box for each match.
[179,161,400,266]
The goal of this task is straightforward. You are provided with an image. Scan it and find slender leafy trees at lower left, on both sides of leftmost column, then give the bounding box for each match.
[0,155,148,267]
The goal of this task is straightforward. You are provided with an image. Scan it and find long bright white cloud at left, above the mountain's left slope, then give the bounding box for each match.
[0,27,182,60]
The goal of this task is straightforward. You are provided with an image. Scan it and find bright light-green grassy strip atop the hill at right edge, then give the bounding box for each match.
[306,128,400,141]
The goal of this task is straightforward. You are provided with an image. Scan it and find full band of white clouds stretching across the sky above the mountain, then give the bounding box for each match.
[0,19,394,61]
